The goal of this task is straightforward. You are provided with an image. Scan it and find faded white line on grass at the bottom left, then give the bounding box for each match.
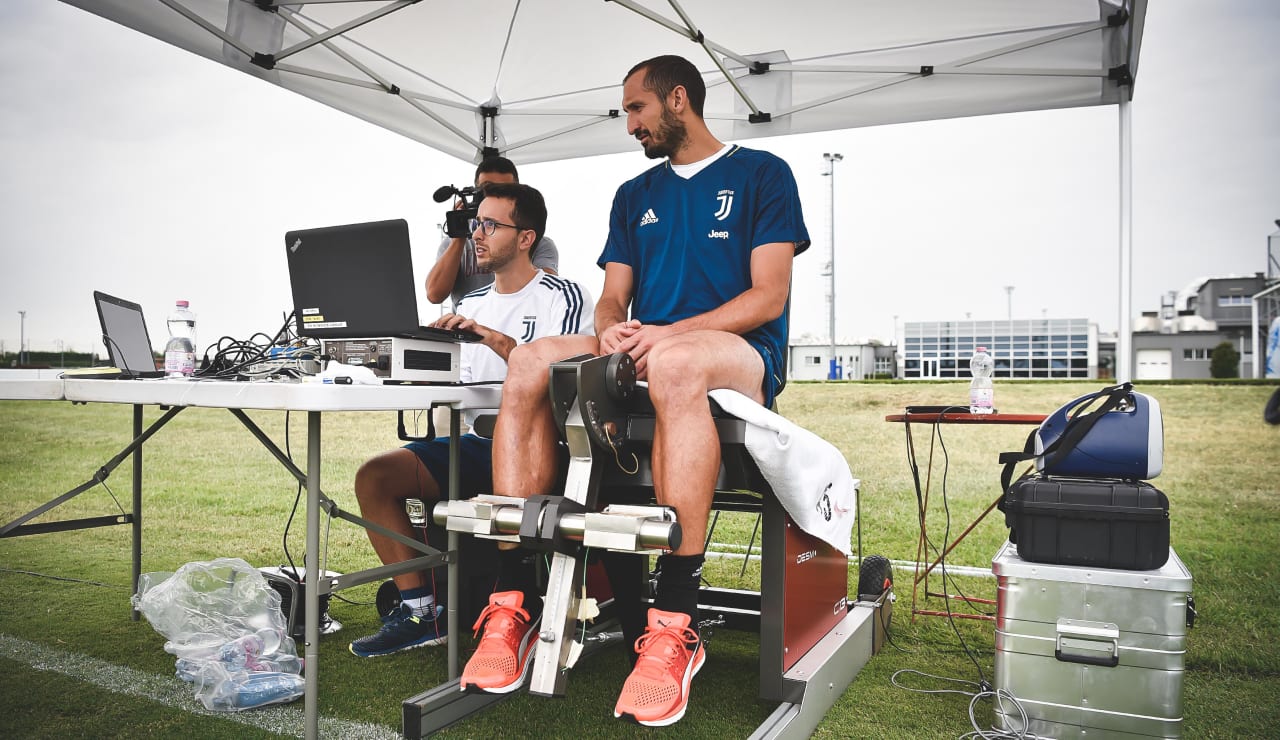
[0,634,401,740]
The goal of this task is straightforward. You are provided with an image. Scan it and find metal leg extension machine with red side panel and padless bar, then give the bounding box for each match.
[403,355,891,737]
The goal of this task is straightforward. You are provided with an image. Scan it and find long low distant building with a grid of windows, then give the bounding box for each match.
[899,319,1098,380]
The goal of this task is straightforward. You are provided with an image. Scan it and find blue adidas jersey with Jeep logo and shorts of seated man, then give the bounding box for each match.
[598,146,809,402]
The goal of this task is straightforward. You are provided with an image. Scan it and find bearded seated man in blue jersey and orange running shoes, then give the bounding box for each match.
[462,56,809,726]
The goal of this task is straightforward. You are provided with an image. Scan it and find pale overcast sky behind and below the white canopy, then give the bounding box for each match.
[0,0,1280,352]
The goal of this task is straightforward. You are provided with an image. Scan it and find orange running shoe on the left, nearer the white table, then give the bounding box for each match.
[460,591,538,694]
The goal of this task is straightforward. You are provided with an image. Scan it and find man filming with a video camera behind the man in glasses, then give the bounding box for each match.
[426,156,559,311]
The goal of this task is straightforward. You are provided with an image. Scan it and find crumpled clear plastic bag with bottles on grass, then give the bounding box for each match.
[133,558,302,712]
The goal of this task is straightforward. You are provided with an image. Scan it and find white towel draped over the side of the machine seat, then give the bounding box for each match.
[709,388,860,556]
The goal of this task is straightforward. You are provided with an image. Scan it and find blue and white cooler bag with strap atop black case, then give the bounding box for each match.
[1034,383,1165,480]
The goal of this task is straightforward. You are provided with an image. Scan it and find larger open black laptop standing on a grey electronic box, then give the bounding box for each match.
[284,219,480,342]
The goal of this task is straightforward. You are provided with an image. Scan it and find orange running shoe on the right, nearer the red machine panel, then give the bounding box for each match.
[613,609,707,727]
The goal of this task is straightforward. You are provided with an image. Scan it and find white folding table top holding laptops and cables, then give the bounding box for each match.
[0,376,502,411]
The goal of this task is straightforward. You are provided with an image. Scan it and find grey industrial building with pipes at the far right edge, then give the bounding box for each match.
[1133,273,1270,380]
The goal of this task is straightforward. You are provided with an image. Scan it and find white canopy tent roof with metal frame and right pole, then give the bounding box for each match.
[55,0,1146,378]
